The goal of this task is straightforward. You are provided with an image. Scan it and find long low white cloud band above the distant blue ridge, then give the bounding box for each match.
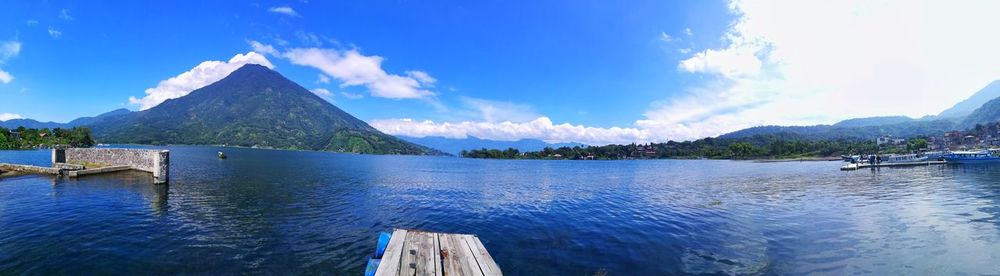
[371,117,646,145]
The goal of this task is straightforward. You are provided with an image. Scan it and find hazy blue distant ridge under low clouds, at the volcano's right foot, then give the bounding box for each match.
[397,136,585,155]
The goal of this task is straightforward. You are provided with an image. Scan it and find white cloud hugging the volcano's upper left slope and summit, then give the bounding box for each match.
[128,52,274,110]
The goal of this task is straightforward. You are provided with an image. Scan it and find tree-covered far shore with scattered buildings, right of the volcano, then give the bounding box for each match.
[461,123,1000,163]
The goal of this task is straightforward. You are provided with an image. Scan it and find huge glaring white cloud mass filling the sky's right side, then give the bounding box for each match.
[656,0,1000,140]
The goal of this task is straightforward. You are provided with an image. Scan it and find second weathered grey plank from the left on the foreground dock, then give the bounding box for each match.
[399,231,440,276]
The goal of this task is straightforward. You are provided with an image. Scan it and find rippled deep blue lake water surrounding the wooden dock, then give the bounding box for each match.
[0,147,1000,275]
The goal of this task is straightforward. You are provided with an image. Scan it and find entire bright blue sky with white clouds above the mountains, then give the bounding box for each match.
[0,1,1000,144]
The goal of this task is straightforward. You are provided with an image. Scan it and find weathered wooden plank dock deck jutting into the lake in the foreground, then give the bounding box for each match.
[375,229,503,276]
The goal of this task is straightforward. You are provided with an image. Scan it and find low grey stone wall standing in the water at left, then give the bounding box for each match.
[52,148,170,183]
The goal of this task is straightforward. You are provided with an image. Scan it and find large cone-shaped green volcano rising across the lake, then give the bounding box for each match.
[89,65,440,155]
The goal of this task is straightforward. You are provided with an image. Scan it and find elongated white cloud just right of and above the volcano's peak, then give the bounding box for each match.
[281,48,434,99]
